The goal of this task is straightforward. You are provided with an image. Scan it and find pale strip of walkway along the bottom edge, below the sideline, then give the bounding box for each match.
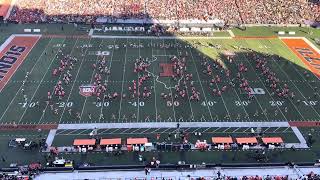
[35,166,320,180]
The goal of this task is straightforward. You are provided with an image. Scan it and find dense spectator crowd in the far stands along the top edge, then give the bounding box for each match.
[8,0,320,24]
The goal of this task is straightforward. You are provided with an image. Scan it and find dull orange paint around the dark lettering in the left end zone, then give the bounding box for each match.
[0,36,40,92]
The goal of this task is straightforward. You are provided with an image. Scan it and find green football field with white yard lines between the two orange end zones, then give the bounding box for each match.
[0,36,320,124]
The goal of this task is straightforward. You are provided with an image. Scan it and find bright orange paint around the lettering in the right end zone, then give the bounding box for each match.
[282,39,320,77]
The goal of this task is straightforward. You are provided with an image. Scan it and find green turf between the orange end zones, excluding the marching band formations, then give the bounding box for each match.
[0,38,320,124]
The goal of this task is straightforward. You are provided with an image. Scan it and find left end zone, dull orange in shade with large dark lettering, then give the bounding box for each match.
[0,36,40,92]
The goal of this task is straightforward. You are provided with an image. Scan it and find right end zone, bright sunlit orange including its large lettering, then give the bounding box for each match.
[282,39,320,78]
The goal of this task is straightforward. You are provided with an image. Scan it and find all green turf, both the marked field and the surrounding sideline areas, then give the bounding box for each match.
[0,24,320,165]
